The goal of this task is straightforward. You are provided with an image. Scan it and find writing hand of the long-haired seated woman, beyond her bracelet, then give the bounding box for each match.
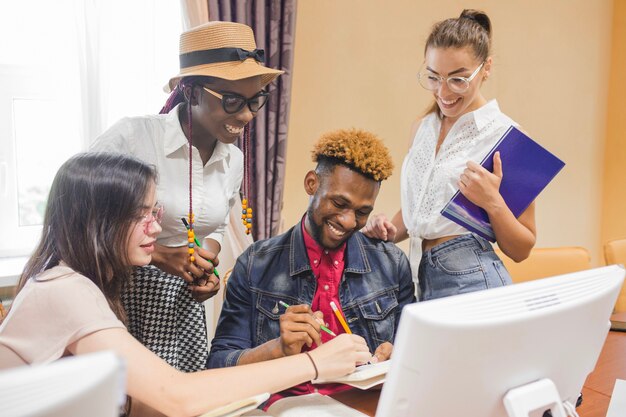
[309,333,372,379]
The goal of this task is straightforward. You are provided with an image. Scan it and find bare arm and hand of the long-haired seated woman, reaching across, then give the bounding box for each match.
[68,329,370,416]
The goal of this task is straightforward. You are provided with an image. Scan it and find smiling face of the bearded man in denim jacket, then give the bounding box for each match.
[304,165,380,249]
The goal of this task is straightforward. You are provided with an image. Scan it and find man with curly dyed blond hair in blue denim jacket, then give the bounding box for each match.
[208,129,415,406]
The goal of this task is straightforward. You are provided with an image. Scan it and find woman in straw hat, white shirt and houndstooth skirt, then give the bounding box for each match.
[92,22,283,371]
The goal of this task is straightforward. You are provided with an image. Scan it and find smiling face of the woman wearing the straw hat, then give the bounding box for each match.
[192,76,262,144]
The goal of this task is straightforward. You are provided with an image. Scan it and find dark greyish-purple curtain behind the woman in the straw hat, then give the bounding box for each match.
[207,0,296,240]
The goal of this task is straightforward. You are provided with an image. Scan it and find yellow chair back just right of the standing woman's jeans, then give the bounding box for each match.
[496,246,591,283]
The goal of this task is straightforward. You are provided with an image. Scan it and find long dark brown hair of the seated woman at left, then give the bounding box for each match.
[18,153,157,321]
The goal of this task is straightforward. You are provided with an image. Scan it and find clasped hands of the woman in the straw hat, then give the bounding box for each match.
[152,244,220,302]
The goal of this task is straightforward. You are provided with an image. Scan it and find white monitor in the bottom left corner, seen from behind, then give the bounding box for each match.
[0,352,126,417]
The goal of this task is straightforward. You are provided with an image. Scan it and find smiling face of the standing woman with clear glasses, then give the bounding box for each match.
[424,47,491,121]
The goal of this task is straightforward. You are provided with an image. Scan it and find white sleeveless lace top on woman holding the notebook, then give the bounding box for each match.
[401,100,517,275]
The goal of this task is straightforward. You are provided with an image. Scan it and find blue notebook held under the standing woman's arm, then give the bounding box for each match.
[441,126,565,242]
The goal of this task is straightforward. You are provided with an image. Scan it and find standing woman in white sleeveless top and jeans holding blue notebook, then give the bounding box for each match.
[363,10,536,300]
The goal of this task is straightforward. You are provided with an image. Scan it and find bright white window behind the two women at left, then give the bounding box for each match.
[0,0,182,257]
